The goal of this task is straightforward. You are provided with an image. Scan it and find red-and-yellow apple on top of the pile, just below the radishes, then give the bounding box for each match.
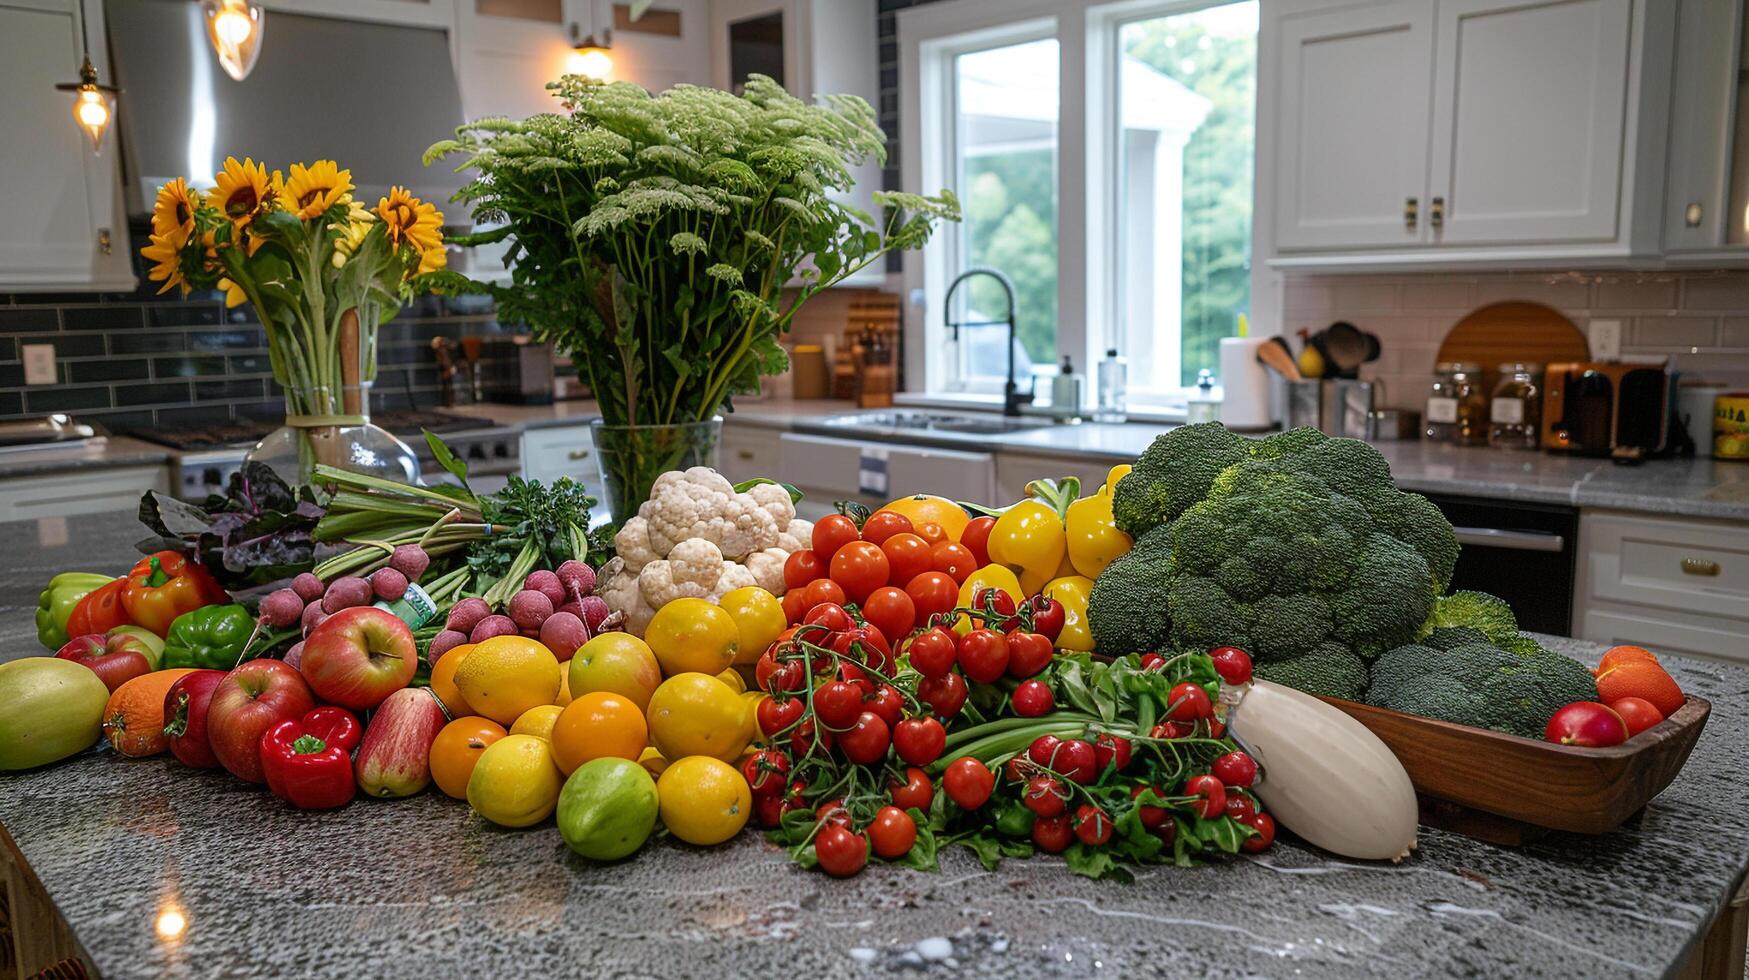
[297,606,420,711]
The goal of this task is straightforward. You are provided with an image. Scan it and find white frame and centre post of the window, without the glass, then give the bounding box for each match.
[897,0,1280,415]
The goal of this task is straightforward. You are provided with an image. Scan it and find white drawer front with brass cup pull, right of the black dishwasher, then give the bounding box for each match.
[1572,511,1749,662]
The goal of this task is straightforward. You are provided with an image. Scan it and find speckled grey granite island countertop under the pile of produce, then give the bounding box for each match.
[0,515,1749,978]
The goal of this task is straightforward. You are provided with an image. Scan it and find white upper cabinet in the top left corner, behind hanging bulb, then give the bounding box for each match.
[0,0,135,292]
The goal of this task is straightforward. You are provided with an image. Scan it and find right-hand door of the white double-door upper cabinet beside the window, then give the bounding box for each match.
[1429,0,1634,245]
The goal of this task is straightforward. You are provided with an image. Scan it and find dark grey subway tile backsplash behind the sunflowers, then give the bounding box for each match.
[0,229,514,429]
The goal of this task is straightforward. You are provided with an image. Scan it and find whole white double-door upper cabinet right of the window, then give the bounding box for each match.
[1259,0,1676,270]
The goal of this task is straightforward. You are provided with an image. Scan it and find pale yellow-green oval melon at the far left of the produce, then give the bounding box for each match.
[0,656,108,770]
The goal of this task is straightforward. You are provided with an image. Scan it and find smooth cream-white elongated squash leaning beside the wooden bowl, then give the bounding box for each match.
[1226,681,1417,861]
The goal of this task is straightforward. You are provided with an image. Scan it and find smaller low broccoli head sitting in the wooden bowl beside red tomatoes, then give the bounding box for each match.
[1366,644,1597,739]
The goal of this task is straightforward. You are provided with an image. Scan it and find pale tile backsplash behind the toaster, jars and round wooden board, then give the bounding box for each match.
[1282,271,1749,410]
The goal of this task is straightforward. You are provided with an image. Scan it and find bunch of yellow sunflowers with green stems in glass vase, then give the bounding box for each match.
[140,158,453,476]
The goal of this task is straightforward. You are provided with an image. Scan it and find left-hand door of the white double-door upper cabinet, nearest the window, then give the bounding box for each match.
[1275,2,1432,250]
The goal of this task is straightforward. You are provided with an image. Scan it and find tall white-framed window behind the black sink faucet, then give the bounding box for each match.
[899,0,1259,406]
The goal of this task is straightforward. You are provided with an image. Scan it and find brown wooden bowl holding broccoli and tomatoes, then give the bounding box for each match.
[1322,697,1712,847]
